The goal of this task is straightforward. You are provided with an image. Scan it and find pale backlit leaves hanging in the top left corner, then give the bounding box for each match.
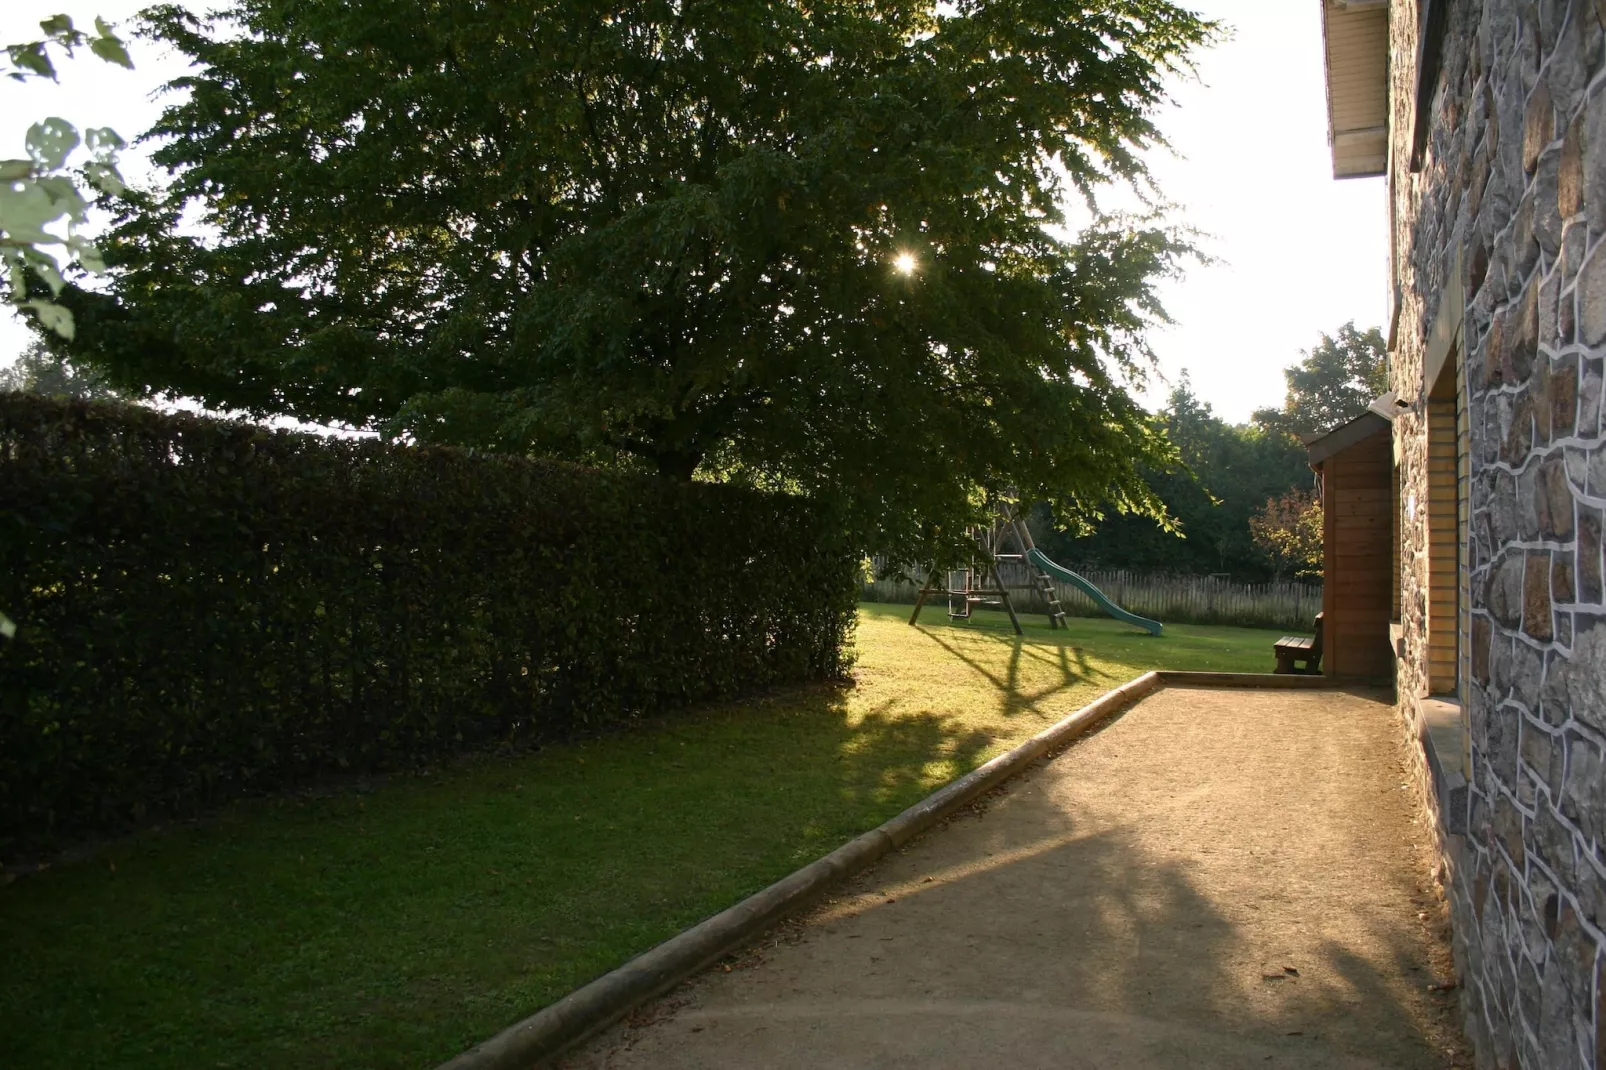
[0,14,133,339]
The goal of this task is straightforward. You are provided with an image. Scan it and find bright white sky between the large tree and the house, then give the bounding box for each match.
[1150,0,1388,421]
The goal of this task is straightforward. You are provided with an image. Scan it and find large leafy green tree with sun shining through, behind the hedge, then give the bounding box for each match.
[46,0,1211,559]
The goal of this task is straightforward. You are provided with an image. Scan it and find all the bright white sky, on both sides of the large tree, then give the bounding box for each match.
[0,0,1388,421]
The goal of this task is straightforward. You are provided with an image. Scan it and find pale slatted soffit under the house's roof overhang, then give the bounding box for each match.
[1320,0,1389,178]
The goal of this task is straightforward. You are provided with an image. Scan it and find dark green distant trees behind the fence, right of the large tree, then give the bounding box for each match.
[1034,374,1310,582]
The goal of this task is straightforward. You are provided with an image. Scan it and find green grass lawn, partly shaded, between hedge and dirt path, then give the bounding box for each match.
[0,606,1278,1070]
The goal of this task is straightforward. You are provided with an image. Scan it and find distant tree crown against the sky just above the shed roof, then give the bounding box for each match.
[1254,320,1389,437]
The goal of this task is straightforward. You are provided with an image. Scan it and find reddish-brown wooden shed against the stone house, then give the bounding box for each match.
[1306,398,1399,680]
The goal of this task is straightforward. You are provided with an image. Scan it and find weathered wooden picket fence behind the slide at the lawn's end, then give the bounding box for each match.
[861,559,1322,631]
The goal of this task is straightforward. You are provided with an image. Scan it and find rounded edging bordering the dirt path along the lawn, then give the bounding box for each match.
[438,661,1333,1070]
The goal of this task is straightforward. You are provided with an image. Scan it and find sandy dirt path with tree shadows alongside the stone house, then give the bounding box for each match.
[564,689,1469,1070]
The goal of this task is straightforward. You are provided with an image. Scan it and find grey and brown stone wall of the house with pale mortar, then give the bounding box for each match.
[1391,0,1606,1070]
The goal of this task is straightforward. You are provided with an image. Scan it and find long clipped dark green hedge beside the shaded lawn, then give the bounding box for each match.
[0,394,858,856]
